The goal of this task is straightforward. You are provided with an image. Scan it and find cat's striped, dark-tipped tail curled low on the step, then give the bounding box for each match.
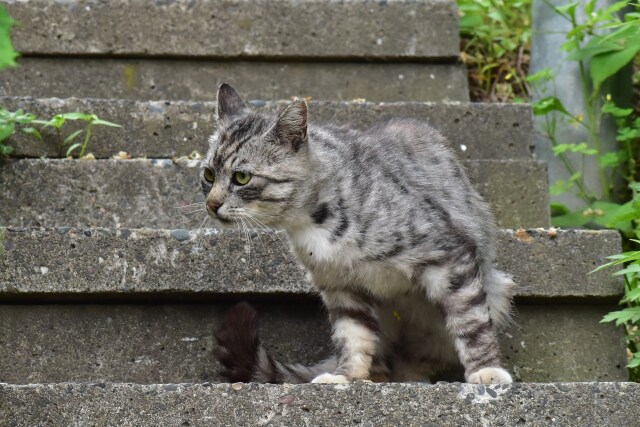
[215,302,337,384]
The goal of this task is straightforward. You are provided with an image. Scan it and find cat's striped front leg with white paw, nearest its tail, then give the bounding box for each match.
[312,290,380,383]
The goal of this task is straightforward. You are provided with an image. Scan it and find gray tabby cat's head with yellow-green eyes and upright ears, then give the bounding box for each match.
[200,83,309,231]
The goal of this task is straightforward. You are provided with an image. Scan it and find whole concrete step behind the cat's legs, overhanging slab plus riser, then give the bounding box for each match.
[0,228,626,383]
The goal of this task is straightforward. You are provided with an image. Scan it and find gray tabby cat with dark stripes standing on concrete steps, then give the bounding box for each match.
[201,84,514,384]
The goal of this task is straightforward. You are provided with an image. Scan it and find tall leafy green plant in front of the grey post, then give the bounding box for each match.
[527,0,640,214]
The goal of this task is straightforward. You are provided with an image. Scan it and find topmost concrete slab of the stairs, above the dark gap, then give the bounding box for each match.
[7,0,459,60]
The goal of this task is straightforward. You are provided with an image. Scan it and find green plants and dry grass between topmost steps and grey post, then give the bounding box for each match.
[457,0,531,101]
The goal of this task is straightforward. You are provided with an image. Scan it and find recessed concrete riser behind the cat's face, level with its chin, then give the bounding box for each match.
[0,159,549,228]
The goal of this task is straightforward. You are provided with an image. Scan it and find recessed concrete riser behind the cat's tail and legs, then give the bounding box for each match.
[0,299,627,384]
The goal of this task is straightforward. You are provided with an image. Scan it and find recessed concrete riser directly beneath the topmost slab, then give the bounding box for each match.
[0,58,469,102]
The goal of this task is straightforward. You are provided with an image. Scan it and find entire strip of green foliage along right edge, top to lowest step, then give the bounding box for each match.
[527,0,640,380]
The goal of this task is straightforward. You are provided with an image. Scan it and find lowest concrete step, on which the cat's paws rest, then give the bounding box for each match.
[0,383,640,427]
